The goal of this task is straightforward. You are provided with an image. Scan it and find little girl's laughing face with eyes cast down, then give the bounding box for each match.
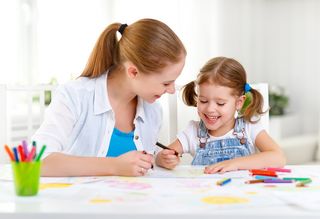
[197,83,244,137]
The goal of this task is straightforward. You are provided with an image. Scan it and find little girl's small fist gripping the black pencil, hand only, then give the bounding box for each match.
[156,149,180,170]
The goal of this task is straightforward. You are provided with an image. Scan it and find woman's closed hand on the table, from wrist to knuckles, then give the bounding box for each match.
[114,151,154,176]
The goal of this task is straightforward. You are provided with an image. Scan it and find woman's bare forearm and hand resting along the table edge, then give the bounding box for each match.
[41,151,153,176]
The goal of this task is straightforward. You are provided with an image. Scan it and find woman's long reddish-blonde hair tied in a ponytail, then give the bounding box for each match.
[81,19,186,78]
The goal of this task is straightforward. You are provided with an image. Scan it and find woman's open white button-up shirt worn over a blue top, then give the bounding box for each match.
[32,72,162,158]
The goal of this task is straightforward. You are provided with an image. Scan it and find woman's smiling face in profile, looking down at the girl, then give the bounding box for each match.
[133,57,185,103]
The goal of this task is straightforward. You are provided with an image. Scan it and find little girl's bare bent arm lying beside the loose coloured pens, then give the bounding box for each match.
[205,130,286,173]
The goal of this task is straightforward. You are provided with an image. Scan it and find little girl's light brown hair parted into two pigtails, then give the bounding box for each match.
[182,57,265,123]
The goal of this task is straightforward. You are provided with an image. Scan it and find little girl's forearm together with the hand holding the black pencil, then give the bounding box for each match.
[156,139,183,170]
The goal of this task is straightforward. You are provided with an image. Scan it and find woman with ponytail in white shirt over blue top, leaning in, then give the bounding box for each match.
[32,19,186,176]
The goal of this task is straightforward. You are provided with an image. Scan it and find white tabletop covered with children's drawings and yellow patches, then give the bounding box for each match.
[0,166,320,219]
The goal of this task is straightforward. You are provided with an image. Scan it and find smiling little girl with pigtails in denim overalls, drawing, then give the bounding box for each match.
[156,57,286,173]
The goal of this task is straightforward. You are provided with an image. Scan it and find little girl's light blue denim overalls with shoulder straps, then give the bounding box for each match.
[191,118,253,165]
